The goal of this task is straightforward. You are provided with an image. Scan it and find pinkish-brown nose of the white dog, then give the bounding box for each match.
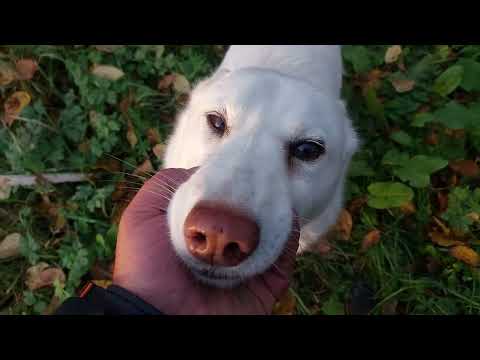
[184,202,260,267]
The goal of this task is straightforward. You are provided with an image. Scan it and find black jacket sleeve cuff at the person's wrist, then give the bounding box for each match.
[55,283,163,315]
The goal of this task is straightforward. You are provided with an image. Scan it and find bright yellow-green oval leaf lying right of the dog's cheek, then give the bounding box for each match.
[368,182,413,209]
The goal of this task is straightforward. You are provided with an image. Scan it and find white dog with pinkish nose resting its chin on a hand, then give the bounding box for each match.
[164,45,358,287]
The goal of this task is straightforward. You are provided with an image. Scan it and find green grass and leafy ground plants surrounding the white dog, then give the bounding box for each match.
[0,45,480,314]
